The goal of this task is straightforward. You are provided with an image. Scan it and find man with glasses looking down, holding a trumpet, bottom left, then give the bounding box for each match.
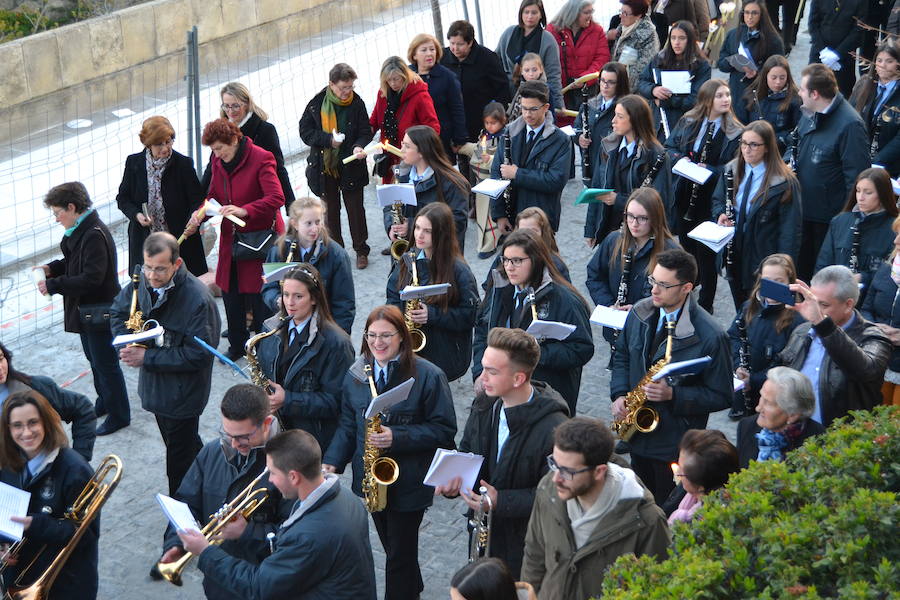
[150,383,292,599]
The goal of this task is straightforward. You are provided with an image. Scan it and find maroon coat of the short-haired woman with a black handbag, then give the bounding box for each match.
[206,138,284,294]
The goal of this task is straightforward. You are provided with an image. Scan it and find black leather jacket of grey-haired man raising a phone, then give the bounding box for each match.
[776,311,892,427]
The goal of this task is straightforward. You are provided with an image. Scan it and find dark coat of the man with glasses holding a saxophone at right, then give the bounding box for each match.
[609,295,733,462]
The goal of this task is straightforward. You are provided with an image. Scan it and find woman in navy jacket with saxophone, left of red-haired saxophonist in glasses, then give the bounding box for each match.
[257,264,353,448]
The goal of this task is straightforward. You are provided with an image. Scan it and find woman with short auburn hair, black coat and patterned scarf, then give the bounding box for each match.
[116,116,207,276]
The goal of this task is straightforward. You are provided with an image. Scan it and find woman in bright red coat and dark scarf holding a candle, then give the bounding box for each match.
[369,56,441,183]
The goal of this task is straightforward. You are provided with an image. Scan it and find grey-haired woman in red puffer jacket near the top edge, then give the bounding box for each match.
[547,0,609,126]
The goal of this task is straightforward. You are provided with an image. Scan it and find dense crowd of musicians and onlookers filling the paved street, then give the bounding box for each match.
[0,0,900,600]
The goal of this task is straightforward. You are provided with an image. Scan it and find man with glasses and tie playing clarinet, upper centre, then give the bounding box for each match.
[491,81,572,234]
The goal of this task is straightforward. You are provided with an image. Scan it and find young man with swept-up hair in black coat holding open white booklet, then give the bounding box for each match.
[435,327,569,578]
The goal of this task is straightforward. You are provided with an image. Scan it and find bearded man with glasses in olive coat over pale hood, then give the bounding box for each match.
[522,417,672,600]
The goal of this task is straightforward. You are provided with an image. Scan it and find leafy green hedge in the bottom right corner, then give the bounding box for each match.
[601,407,900,600]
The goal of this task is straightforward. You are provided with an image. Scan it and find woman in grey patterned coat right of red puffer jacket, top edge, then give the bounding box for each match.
[606,0,656,89]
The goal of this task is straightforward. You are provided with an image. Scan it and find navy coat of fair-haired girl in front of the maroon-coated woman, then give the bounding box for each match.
[262,239,356,334]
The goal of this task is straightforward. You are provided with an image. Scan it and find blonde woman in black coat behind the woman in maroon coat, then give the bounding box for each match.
[203,81,294,207]
